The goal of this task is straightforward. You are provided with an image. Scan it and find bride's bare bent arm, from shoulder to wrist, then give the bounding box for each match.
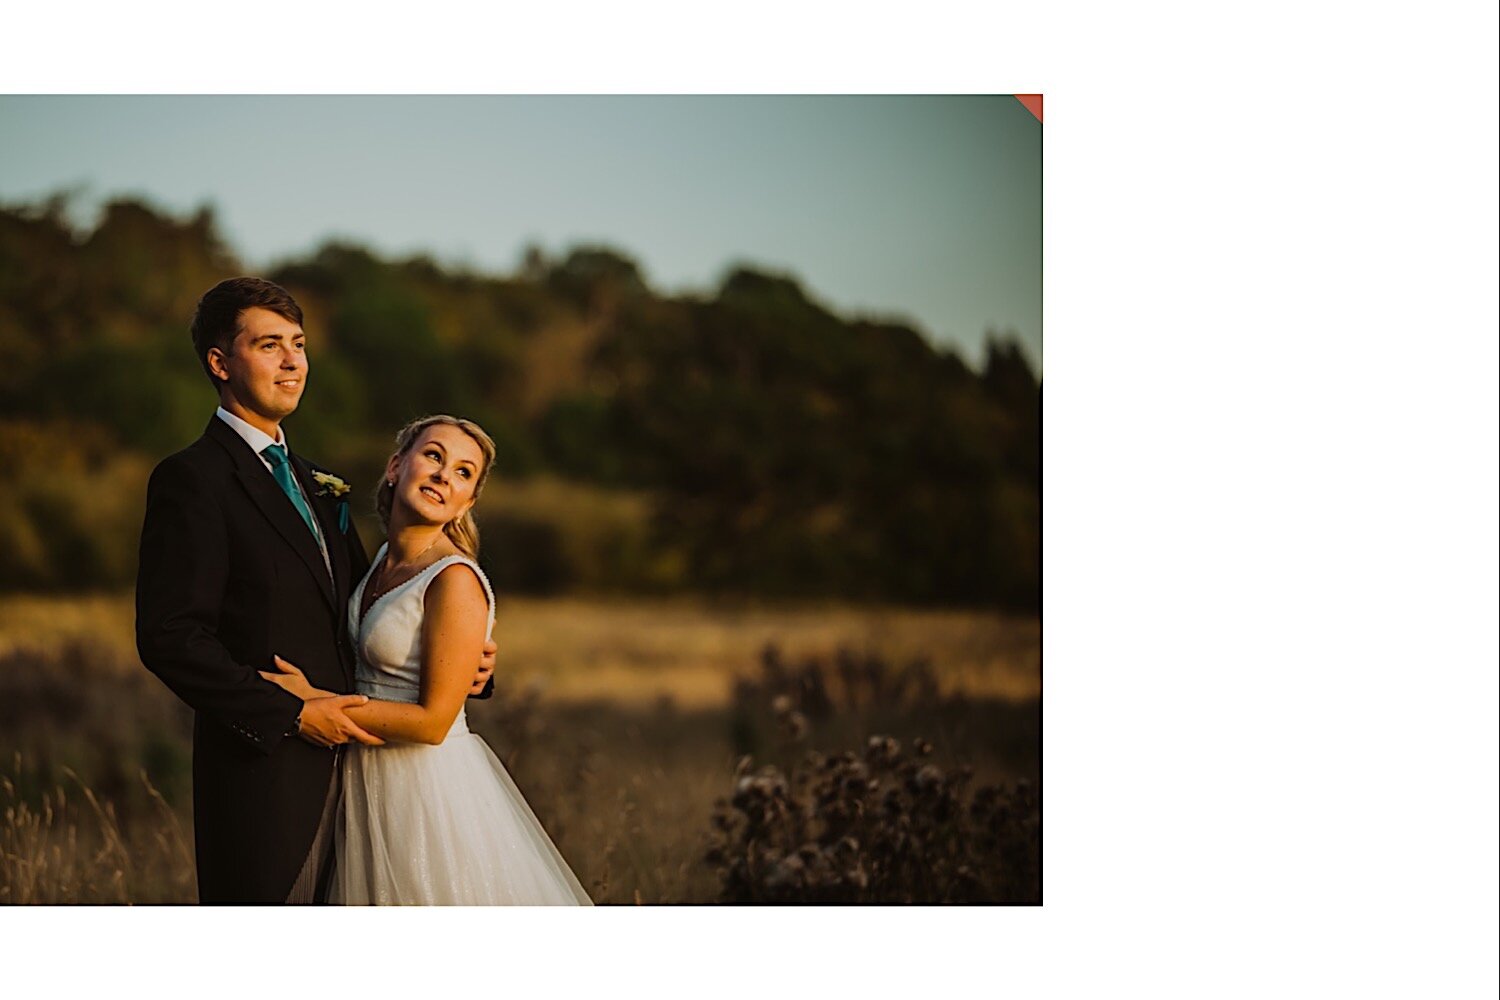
[337,562,489,744]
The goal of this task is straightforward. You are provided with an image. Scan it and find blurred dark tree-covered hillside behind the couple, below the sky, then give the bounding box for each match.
[0,195,1041,610]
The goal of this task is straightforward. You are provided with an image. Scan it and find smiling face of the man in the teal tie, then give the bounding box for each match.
[209,306,308,429]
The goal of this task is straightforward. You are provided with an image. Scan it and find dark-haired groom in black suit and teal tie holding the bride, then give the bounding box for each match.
[135,277,495,903]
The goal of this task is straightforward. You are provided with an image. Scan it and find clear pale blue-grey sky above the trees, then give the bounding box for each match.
[0,96,1043,370]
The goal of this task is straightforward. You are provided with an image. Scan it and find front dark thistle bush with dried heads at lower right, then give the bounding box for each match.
[705,735,1041,904]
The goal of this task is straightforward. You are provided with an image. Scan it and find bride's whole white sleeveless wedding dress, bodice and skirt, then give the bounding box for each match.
[329,546,591,906]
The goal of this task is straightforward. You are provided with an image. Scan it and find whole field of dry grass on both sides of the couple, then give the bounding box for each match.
[0,594,1041,903]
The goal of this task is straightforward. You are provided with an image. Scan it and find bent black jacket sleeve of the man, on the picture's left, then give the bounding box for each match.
[135,457,302,754]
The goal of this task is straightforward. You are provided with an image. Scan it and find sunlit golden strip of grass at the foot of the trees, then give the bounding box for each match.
[0,594,1041,709]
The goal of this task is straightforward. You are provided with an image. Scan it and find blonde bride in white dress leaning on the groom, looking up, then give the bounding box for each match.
[261,415,590,906]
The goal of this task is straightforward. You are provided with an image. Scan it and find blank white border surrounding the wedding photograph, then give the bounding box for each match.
[0,0,1500,999]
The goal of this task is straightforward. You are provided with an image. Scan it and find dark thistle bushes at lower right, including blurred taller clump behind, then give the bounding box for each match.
[705,645,1041,903]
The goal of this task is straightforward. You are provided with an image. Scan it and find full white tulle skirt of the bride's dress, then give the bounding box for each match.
[329,723,591,906]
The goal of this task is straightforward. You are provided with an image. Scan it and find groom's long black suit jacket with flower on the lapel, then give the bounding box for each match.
[135,417,369,903]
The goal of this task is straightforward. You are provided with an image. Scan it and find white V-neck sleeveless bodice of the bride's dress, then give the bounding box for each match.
[350,544,495,735]
